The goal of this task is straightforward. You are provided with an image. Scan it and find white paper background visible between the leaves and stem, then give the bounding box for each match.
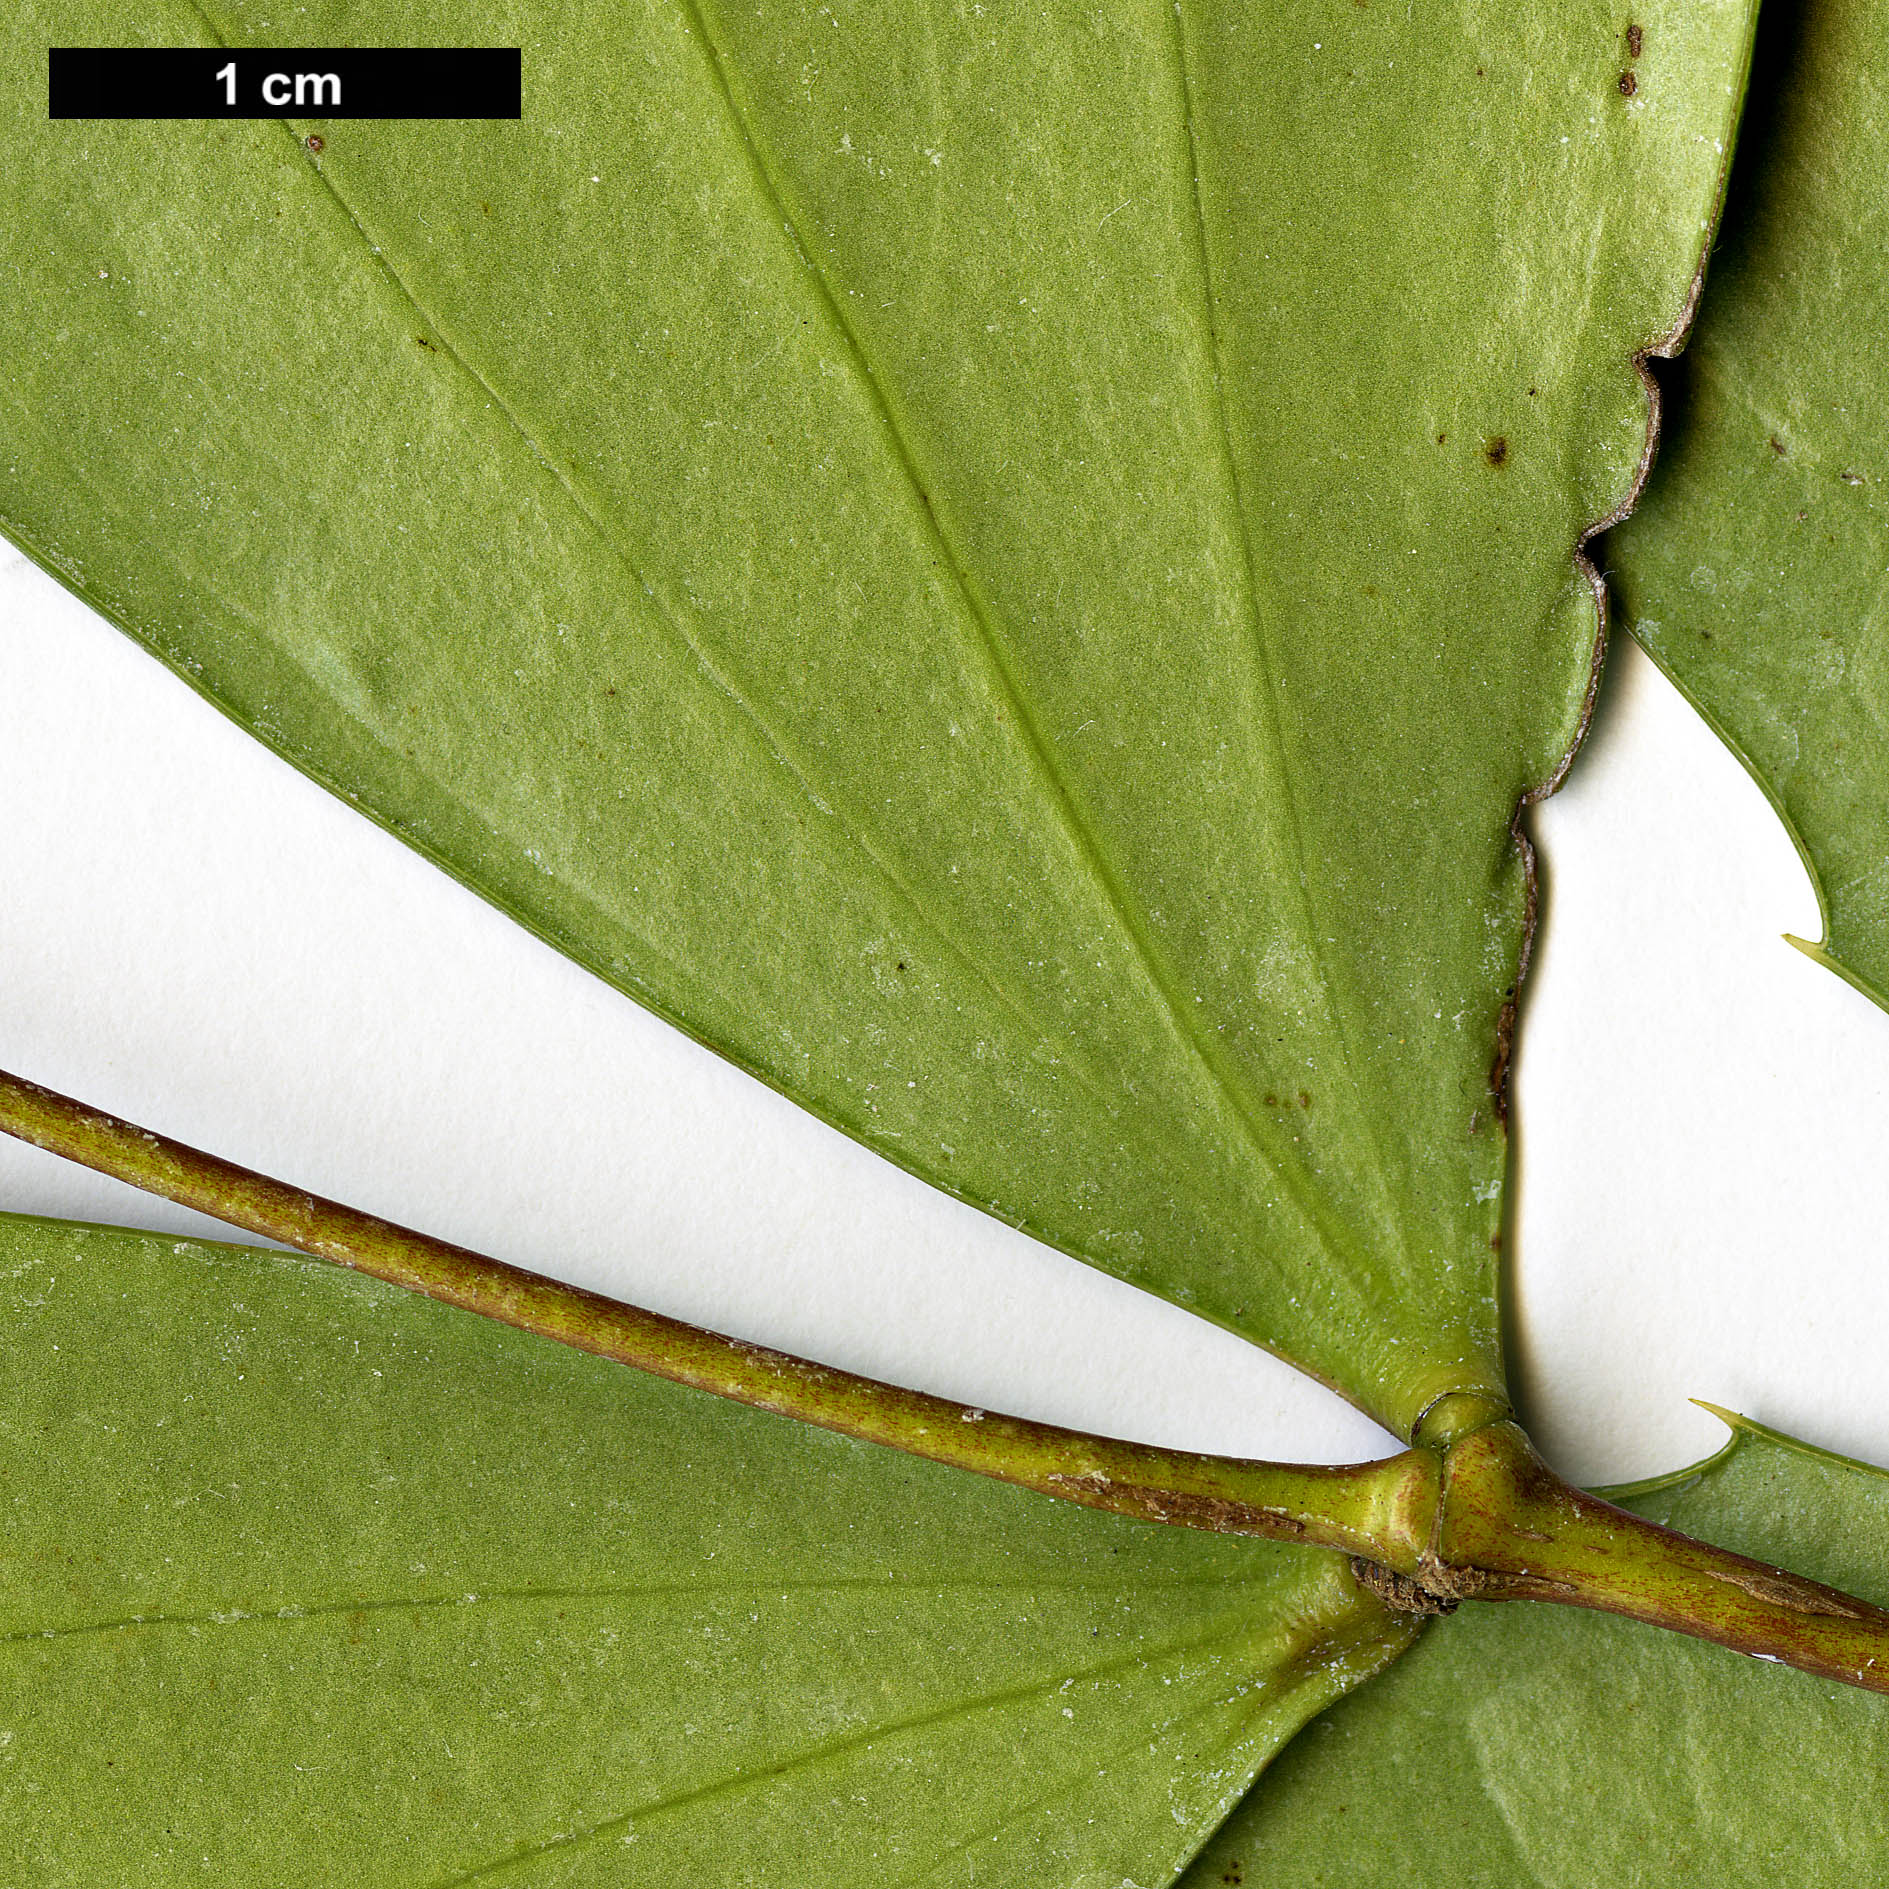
[0,548,1889,1481]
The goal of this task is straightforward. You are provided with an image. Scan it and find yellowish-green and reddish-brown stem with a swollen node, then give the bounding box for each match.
[0,1071,1889,1693]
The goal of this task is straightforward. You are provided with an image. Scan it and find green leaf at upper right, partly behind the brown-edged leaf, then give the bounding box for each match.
[1608,4,1889,1005]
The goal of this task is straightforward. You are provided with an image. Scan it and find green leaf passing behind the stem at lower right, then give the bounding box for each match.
[1183,1419,1889,1889]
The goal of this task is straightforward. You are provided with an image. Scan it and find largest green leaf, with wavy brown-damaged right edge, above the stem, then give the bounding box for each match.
[0,0,1751,1434]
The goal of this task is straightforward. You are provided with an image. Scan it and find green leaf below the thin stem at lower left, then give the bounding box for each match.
[0,1217,1409,1889]
